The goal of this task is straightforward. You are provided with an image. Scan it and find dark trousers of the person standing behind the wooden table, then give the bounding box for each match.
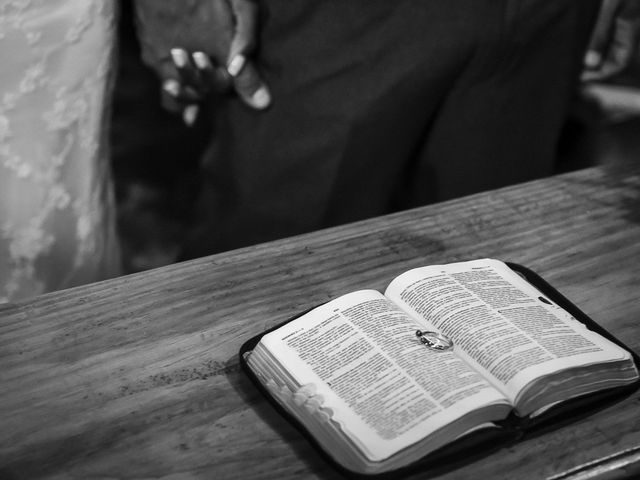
[180,0,599,257]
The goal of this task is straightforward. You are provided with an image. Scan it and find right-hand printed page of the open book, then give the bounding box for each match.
[386,259,628,402]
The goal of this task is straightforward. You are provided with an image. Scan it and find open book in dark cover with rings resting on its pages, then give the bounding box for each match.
[243,259,638,474]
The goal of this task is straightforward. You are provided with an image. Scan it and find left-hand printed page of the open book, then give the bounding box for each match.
[261,290,508,460]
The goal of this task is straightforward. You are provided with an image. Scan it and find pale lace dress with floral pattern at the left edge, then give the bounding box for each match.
[0,0,119,302]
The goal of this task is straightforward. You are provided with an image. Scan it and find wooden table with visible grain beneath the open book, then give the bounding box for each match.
[0,166,640,480]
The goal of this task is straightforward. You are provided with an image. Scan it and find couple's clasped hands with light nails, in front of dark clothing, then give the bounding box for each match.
[135,0,271,118]
